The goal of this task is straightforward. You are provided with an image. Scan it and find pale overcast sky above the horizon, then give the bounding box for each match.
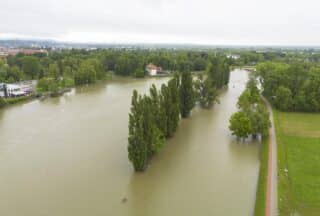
[0,0,320,45]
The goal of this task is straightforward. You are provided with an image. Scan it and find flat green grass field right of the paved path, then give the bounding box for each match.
[274,111,320,216]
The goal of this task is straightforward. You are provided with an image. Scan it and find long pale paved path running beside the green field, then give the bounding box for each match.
[264,99,278,216]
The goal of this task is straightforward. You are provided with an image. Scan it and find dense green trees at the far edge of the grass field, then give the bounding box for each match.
[257,62,320,112]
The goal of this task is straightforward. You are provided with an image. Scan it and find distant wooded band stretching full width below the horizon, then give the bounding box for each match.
[0,48,320,85]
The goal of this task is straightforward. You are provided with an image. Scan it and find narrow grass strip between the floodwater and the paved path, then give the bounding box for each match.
[254,137,269,216]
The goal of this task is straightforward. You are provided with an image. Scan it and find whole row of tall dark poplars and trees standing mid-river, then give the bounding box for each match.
[128,58,230,171]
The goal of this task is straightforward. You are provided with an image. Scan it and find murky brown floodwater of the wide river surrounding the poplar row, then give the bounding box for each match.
[0,70,259,216]
